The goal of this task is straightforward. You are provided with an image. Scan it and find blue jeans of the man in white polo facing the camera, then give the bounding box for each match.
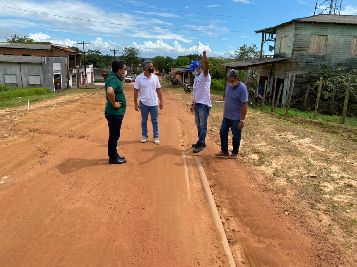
[140,101,159,138]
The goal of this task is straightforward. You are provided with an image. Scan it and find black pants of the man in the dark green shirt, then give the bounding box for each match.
[105,114,123,159]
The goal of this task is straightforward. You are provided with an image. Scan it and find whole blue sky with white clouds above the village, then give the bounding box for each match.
[0,0,357,57]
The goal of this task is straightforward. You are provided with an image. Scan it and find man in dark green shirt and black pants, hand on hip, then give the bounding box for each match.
[105,61,127,164]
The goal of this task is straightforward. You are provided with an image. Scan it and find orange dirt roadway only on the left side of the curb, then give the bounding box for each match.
[0,87,228,266]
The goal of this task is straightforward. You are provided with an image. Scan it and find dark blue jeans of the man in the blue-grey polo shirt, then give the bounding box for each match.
[220,118,242,154]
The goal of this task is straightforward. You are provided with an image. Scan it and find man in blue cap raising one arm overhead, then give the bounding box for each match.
[190,51,212,153]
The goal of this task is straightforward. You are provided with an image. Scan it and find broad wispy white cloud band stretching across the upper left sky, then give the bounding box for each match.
[0,0,190,42]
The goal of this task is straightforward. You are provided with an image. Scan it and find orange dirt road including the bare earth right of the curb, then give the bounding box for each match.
[0,86,329,267]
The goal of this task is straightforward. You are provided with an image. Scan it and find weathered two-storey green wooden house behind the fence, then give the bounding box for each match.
[226,14,357,105]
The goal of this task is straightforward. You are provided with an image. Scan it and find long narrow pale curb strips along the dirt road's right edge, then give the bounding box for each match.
[182,152,236,267]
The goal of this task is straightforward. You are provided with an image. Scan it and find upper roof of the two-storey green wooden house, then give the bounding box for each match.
[255,14,357,33]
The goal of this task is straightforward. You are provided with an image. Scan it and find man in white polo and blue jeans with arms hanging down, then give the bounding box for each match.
[134,60,164,145]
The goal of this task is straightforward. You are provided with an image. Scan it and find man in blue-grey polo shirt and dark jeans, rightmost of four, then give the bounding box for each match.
[216,70,248,159]
